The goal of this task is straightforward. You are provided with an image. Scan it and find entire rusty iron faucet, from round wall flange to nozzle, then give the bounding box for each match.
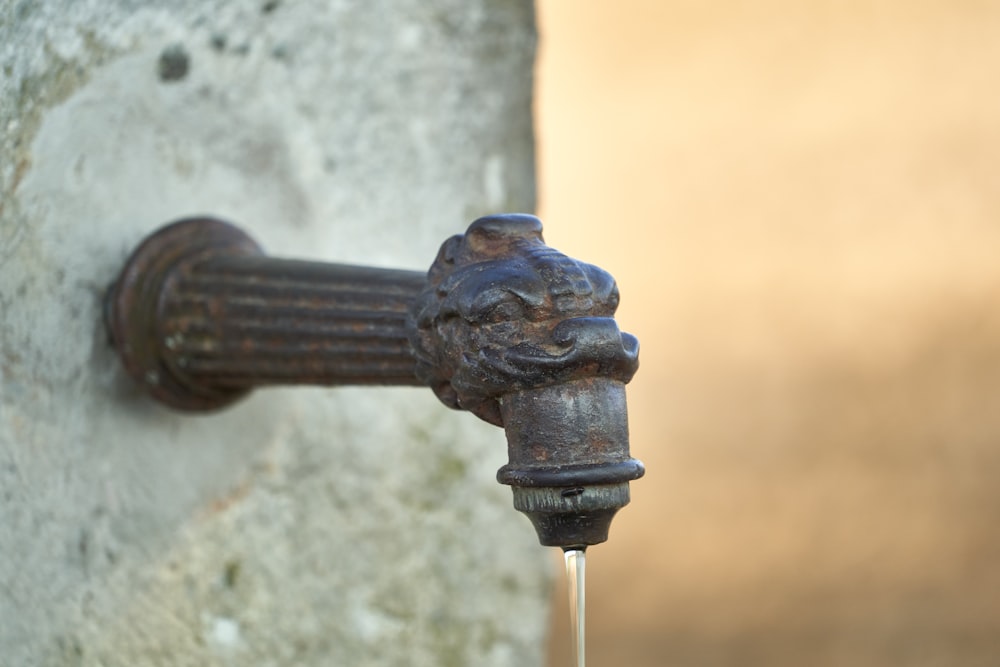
[105,214,644,550]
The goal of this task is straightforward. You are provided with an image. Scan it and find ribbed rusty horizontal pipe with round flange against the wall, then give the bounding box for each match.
[105,218,426,411]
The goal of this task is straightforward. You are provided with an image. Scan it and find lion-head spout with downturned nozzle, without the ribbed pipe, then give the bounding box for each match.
[410,215,644,549]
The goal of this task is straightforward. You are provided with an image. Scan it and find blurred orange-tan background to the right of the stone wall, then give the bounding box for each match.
[537,0,1000,667]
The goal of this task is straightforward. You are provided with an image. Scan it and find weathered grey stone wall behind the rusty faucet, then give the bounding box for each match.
[0,0,549,667]
